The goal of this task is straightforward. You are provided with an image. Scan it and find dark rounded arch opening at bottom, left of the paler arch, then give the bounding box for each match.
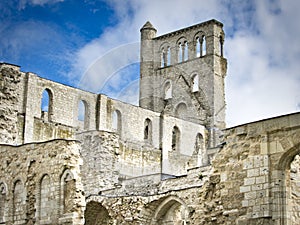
[84,201,112,225]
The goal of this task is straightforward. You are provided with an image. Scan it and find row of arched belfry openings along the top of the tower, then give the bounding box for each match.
[160,32,224,68]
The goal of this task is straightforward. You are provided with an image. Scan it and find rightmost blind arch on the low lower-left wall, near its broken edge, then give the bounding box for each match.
[60,170,75,214]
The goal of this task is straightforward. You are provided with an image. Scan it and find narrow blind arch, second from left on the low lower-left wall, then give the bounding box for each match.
[13,180,27,224]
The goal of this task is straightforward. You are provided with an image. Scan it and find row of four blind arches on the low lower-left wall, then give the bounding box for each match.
[0,170,75,224]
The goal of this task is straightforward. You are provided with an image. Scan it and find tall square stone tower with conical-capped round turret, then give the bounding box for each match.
[139,20,227,147]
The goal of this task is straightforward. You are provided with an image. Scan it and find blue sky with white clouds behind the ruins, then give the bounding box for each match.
[0,0,300,127]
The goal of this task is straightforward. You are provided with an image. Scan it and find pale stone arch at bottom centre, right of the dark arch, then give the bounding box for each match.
[151,196,189,225]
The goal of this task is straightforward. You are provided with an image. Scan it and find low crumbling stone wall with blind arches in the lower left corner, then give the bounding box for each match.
[0,140,85,224]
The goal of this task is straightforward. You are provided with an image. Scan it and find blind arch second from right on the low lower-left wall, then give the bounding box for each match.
[39,175,54,221]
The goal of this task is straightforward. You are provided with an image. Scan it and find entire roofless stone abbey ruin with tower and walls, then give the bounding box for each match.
[0,20,300,225]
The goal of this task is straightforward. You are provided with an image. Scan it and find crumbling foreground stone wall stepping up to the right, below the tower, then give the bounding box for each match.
[86,113,300,225]
